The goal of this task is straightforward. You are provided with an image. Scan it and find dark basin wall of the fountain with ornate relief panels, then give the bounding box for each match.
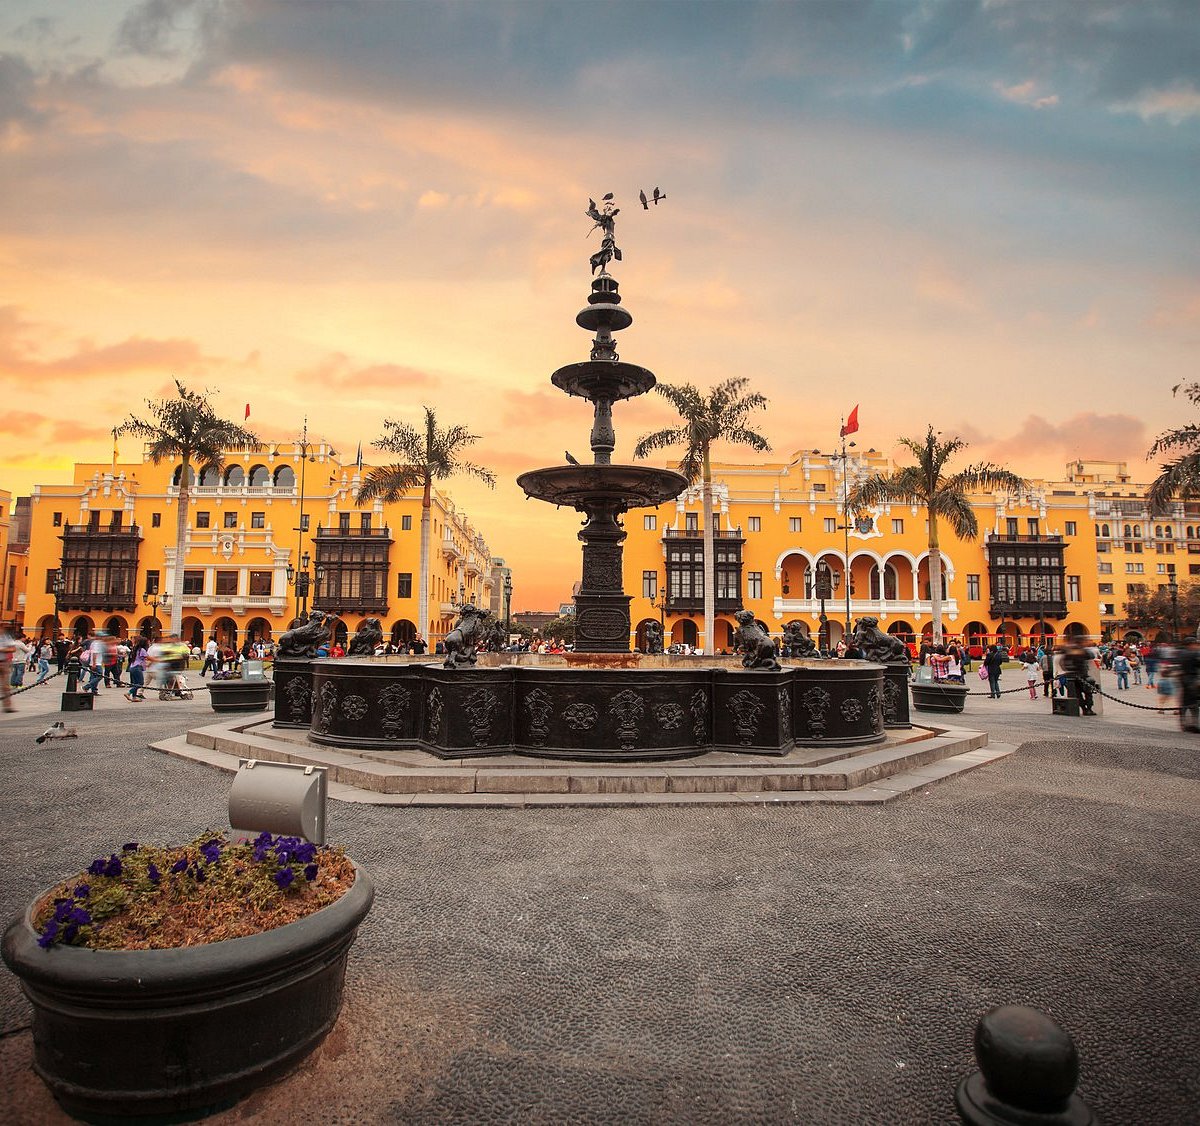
[295,658,884,762]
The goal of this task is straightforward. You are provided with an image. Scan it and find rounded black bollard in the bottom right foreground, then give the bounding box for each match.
[954,1005,1096,1126]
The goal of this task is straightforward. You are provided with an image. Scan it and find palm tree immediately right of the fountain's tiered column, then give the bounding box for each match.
[634,377,770,653]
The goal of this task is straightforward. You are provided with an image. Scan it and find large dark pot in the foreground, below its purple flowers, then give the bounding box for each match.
[2,869,374,1119]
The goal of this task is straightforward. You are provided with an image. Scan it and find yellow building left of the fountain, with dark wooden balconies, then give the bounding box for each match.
[24,442,494,648]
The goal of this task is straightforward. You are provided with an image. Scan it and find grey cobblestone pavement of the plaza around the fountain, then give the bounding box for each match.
[0,675,1200,1126]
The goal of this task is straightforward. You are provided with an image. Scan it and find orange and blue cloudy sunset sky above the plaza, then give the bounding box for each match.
[0,0,1200,609]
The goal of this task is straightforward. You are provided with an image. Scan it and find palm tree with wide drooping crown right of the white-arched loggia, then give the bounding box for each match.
[846,426,1030,645]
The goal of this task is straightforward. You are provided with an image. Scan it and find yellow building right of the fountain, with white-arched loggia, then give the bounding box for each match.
[624,450,1185,651]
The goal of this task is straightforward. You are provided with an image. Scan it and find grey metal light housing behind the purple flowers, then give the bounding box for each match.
[229,759,326,845]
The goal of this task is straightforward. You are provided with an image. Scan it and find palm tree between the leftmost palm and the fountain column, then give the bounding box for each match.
[358,407,496,637]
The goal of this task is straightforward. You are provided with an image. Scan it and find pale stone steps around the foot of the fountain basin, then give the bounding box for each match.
[150,717,1014,807]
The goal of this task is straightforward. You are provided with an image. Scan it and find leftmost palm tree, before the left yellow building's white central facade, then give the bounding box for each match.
[114,379,262,634]
